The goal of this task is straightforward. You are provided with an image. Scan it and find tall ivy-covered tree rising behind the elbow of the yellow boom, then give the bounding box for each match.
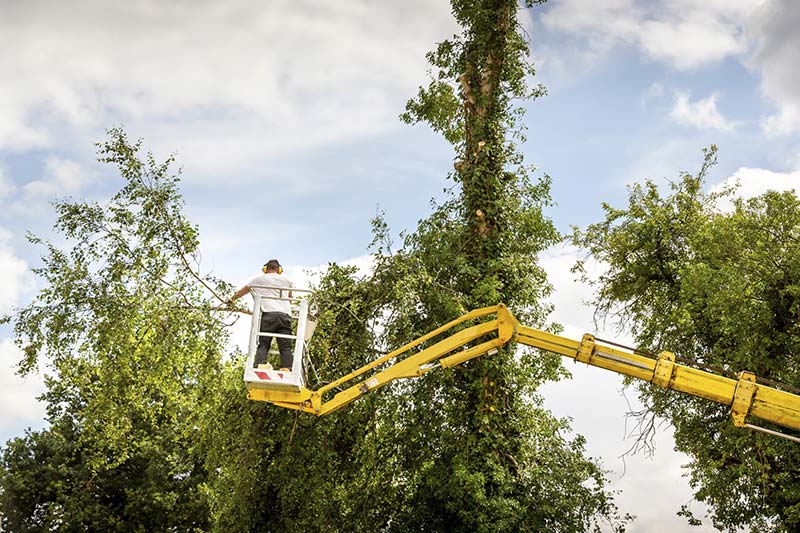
[366,0,622,531]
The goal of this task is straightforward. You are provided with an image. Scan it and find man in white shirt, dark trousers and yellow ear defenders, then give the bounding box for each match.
[231,259,292,372]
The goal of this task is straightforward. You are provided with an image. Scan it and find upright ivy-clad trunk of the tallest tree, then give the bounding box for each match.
[454,0,540,519]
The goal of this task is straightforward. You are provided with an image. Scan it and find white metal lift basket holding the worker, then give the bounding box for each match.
[244,285,316,392]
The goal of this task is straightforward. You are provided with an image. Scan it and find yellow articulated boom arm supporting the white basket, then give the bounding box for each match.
[248,304,800,441]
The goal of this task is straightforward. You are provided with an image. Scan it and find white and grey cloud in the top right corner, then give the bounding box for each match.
[542,0,800,135]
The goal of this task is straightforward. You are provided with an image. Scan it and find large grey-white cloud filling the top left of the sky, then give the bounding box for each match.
[0,0,456,180]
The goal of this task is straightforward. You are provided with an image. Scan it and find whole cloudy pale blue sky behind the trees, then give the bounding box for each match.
[0,0,800,532]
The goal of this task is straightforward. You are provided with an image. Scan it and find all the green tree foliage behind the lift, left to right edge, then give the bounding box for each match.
[23,0,800,532]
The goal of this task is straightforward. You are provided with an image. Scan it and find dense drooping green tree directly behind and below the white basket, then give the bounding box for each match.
[203,264,403,532]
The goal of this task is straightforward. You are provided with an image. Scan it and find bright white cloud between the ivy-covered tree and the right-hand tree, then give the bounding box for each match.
[539,245,715,533]
